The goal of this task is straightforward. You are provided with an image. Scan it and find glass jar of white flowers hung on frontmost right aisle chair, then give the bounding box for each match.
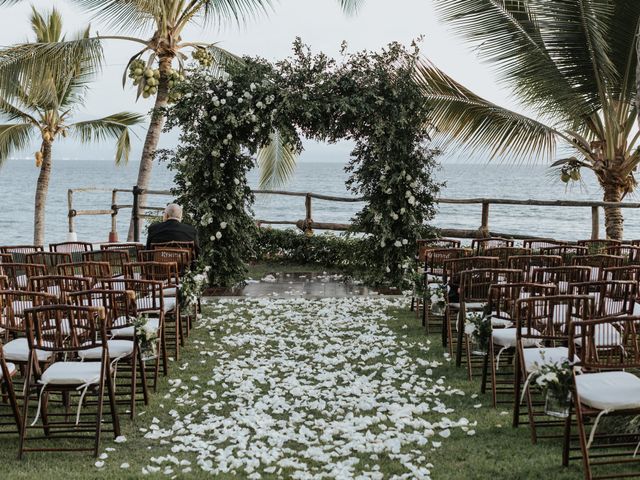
[534,360,573,418]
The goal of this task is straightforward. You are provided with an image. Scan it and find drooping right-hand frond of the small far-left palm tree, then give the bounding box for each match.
[69,112,145,164]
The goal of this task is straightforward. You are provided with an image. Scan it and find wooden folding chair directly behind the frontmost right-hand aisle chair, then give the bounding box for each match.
[512,295,594,443]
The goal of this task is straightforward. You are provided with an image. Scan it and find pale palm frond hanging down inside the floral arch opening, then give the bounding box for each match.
[258,130,297,188]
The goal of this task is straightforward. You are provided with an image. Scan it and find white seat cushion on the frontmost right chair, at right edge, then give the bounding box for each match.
[576,372,640,410]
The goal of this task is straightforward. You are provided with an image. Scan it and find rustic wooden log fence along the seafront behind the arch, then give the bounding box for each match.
[67,187,640,242]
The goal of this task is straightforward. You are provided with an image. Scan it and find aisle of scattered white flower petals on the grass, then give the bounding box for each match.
[143,297,475,479]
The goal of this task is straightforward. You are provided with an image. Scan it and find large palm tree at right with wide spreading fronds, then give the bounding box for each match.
[417,0,640,239]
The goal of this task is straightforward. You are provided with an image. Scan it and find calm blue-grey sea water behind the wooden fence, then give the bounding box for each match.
[0,159,640,244]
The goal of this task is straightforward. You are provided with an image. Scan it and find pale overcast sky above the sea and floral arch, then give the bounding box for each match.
[0,0,519,162]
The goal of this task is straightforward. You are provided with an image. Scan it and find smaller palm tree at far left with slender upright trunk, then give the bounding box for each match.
[0,9,144,245]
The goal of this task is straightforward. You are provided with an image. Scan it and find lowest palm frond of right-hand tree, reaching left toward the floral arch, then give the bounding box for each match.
[415,61,563,160]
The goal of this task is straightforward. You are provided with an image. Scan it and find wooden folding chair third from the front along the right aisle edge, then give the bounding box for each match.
[480,282,557,408]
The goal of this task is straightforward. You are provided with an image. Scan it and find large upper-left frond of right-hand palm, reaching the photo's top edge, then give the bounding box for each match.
[435,0,599,122]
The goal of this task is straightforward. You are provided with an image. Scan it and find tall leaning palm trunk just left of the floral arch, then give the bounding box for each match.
[127,55,173,242]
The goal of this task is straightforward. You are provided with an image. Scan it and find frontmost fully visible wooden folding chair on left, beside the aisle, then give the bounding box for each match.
[19,305,120,458]
